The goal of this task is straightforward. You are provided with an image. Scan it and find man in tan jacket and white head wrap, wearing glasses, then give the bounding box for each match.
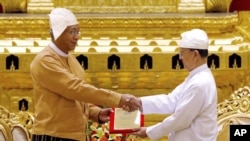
[30,8,141,141]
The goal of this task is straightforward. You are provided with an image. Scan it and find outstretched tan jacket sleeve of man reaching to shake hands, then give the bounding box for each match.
[31,55,121,107]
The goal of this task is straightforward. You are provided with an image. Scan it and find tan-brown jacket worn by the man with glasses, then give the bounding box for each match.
[30,47,121,141]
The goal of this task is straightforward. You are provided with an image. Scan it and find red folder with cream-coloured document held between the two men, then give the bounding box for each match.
[109,108,144,133]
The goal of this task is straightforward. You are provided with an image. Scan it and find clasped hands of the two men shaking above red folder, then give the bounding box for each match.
[119,94,142,112]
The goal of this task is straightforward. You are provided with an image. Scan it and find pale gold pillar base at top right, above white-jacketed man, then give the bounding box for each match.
[178,0,206,13]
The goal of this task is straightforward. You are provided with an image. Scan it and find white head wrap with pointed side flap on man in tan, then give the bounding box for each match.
[49,8,78,40]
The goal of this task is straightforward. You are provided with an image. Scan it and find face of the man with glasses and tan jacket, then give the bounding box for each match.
[55,25,81,53]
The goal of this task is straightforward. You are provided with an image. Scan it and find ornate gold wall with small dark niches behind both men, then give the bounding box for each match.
[0,0,250,129]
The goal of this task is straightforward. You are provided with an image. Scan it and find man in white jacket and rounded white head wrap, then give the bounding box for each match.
[132,29,217,141]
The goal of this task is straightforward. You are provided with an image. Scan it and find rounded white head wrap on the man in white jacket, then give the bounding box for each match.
[180,29,209,49]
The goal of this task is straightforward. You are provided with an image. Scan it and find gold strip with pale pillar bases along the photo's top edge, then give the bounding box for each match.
[0,0,232,13]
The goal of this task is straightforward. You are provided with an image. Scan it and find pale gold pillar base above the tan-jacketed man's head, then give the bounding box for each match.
[27,0,54,14]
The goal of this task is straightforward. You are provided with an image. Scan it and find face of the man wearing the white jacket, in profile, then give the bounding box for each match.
[179,48,195,71]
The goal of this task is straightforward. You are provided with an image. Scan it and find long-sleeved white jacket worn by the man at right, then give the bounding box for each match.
[141,64,217,141]
